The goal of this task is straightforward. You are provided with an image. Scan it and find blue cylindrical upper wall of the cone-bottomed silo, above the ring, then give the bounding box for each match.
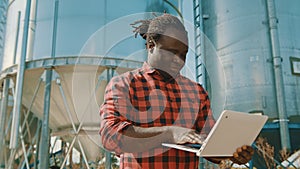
[3,0,177,69]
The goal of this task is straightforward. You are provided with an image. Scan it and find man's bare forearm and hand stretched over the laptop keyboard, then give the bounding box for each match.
[121,125,206,152]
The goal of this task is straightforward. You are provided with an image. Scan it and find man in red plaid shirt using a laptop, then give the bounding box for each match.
[100,14,253,169]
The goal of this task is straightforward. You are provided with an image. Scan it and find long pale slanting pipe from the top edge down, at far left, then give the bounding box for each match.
[9,0,31,149]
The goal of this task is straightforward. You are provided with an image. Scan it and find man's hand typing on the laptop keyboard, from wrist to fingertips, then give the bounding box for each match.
[168,126,206,144]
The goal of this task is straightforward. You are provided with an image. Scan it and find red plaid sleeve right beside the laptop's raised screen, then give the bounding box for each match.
[195,85,215,134]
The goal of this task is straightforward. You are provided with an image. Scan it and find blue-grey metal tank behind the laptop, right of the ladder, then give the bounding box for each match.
[201,0,300,153]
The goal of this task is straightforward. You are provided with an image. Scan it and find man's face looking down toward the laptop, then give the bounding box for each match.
[148,28,188,77]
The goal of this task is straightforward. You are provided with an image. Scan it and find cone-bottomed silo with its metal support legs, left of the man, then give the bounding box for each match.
[0,0,177,168]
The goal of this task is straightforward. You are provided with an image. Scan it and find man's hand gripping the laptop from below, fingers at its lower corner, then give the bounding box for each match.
[230,145,254,164]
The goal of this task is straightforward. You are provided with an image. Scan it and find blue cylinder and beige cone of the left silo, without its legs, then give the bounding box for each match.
[1,0,177,166]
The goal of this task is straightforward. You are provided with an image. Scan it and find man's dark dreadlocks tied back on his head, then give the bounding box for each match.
[130,13,186,43]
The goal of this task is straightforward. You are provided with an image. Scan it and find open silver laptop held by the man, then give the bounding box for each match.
[162,110,268,157]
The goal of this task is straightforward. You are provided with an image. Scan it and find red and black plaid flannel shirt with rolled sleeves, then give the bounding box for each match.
[100,63,215,169]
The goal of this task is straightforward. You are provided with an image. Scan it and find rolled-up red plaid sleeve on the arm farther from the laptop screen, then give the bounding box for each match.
[100,77,131,154]
